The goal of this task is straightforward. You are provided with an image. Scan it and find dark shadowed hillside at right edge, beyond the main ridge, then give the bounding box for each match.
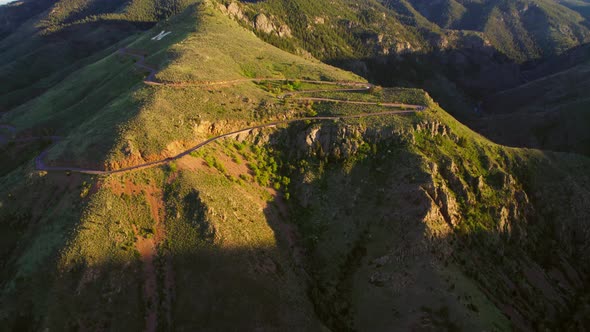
[478,54,590,155]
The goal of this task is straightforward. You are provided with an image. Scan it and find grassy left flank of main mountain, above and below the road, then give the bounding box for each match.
[1,5,366,330]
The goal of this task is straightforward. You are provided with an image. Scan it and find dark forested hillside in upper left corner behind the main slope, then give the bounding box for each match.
[0,0,200,112]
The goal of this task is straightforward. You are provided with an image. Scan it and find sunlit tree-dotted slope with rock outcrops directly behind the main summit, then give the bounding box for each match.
[219,0,432,61]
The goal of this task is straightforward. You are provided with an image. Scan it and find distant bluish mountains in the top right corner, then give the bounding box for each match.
[409,0,590,60]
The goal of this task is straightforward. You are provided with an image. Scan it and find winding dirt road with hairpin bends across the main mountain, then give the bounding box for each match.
[0,48,426,175]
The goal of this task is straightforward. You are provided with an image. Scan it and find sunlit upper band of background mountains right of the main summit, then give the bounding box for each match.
[220,0,590,62]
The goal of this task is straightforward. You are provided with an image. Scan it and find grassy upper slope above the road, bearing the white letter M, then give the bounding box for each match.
[3,0,361,171]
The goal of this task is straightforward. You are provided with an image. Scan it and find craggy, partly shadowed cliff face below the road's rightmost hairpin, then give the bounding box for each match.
[240,107,590,330]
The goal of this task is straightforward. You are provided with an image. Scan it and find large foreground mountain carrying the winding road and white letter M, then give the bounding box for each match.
[0,1,590,331]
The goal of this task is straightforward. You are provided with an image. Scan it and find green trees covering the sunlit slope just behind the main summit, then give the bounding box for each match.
[222,0,426,60]
